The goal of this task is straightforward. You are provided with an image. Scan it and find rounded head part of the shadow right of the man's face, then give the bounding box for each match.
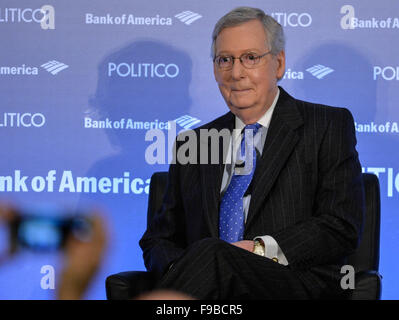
[294,42,377,122]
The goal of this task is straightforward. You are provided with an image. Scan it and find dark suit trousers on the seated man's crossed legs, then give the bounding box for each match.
[158,238,314,300]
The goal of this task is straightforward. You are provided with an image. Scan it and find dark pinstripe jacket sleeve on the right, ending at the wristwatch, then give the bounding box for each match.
[271,108,364,269]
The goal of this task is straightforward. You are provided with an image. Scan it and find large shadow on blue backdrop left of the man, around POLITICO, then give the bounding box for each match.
[79,40,192,298]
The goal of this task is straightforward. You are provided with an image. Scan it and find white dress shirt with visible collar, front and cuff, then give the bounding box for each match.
[220,89,288,265]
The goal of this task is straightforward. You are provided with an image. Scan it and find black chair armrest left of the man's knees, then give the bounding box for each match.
[105,271,156,300]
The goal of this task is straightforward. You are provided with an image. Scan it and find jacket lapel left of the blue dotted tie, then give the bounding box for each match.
[199,112,235,237]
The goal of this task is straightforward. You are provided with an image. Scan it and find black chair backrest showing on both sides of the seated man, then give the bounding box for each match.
[147,172,380,272]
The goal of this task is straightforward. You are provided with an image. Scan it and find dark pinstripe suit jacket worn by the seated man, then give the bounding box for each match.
[140,88,364,294]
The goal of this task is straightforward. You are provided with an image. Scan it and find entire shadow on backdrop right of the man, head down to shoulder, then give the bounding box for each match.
[294,42,394,164]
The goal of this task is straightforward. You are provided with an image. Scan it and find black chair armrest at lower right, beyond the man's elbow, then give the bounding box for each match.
[348,271,382,300]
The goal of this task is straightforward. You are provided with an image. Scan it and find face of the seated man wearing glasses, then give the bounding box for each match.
[214,20,285,124]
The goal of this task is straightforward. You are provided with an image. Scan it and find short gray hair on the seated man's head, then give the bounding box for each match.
[211,7,285,59]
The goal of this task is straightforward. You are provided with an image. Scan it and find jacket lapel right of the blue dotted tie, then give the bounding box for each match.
[246,88,303,228]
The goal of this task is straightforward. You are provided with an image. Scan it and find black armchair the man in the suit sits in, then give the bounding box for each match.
[106,172,382,300]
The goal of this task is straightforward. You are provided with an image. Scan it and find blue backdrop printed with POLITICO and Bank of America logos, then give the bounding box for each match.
[0,0,399,299]
